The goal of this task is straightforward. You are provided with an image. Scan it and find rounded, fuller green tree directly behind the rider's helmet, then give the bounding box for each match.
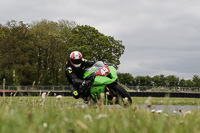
[68,25,125,68]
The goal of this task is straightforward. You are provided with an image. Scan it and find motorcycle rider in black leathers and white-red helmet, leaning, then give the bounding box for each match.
[65,51,95,102]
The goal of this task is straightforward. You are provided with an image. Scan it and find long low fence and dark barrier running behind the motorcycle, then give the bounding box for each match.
[0,85,200,98]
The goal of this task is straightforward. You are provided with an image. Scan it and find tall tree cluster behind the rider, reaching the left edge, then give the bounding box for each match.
[0,20,125,85]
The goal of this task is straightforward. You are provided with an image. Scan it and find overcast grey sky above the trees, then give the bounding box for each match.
[0,0,200,79]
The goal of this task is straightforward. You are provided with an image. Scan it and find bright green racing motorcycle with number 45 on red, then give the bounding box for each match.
[83,61,132,105]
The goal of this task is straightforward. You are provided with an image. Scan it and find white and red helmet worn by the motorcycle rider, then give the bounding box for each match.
[70,51,82,68]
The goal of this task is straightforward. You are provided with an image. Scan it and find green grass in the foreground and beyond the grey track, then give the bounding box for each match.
[0,97,200,133]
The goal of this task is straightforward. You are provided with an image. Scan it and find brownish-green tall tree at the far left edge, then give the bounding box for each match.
[0,20,35,85]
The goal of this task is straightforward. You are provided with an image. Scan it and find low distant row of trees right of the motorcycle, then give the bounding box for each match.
[118,73,200,87]
